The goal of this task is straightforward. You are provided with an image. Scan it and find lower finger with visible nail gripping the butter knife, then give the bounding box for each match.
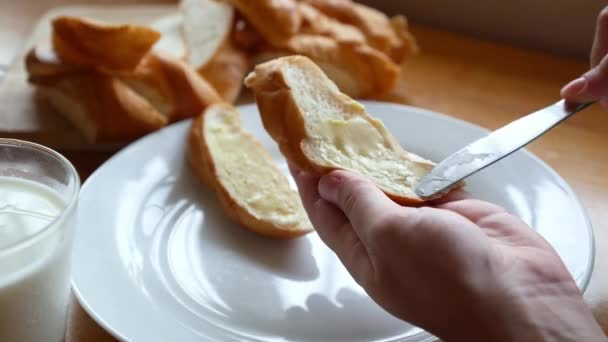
[561,56,608,103]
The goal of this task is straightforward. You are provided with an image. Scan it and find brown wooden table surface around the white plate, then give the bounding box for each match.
[0,0,608,342]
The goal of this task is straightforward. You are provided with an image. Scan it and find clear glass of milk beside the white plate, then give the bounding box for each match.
[0,139,80,342]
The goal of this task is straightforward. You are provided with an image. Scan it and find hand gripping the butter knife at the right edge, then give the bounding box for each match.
[561,7,608,110]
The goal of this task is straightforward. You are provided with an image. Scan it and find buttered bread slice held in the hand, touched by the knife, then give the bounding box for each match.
[245,56,442,205]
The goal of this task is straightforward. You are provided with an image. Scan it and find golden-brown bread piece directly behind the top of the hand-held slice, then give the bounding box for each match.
[254,34,401,98]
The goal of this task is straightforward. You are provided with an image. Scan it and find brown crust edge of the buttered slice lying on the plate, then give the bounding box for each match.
[188,104,312,239]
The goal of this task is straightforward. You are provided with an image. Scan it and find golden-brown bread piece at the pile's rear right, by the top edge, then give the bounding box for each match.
[303,0,418,64]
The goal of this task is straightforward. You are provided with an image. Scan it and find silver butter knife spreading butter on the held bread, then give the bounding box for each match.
[416,100,593,199]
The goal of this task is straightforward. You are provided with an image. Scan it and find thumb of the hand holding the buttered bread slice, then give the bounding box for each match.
[319,170,401,231]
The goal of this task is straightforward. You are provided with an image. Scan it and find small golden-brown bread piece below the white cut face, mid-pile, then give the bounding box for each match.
[198,41,250,103]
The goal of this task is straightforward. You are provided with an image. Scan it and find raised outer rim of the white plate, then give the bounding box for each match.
[70,100,596,342]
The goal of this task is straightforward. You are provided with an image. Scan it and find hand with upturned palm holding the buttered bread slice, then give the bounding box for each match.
[292,168,604,341]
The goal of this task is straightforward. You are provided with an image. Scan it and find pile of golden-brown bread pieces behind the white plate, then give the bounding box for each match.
[26,0,417,143]
